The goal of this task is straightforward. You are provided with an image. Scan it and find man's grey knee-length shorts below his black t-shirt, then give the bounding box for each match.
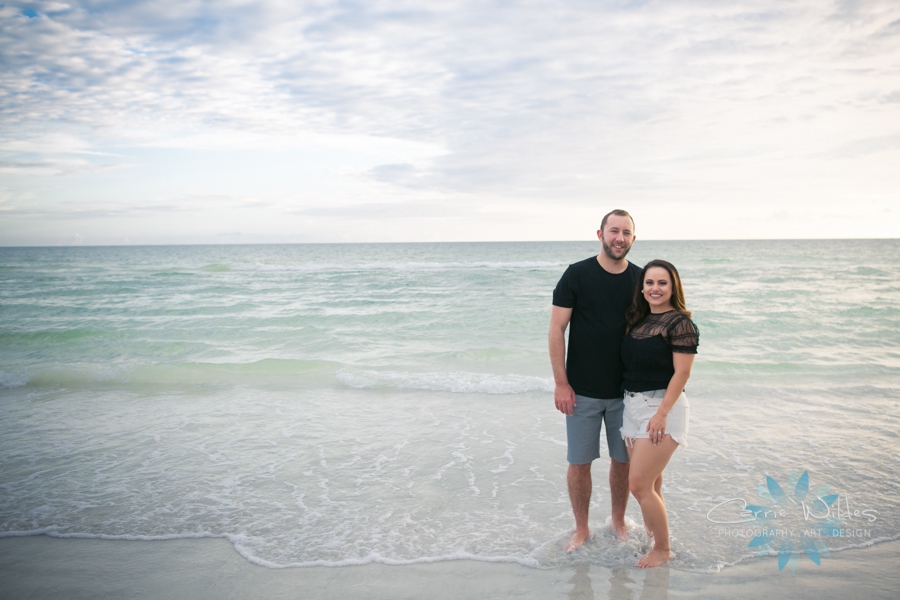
[566,395,628,465]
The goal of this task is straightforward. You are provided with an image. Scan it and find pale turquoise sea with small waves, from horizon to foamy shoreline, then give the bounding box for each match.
[0,240,900,570]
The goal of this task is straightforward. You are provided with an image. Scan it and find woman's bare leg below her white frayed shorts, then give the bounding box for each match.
[628,435,678,568]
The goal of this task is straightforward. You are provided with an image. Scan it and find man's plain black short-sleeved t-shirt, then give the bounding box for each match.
[553,256,641,399]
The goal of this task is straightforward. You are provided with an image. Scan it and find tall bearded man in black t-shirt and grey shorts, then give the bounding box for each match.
[548,210,641,552]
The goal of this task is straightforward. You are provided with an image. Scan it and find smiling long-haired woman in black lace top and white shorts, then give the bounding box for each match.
[621,260,700,568]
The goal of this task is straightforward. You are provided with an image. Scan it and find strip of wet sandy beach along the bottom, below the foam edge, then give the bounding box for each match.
[0,536,900,600]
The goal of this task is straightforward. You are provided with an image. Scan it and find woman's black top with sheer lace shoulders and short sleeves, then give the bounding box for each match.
[622,310,700,392]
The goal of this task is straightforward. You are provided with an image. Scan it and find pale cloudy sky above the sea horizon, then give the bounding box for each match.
[0,0,900,246]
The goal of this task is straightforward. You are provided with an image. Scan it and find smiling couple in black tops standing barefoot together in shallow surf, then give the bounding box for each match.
[548,210,699,567]
